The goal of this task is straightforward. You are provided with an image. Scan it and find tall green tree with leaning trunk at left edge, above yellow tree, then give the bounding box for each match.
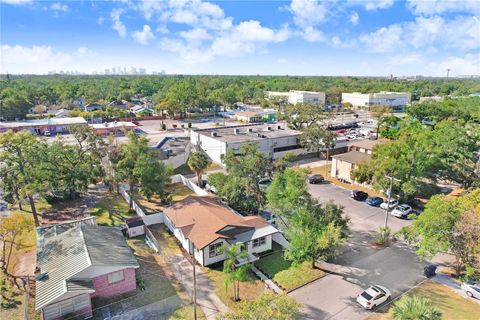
[0,131,47,226]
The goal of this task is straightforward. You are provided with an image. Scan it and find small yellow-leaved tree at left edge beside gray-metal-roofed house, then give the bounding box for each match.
[0,212,34,274]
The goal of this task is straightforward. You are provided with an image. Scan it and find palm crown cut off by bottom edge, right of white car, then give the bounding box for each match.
[390,296,442,320]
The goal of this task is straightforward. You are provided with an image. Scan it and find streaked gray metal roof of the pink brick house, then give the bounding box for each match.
[35,225,139,310]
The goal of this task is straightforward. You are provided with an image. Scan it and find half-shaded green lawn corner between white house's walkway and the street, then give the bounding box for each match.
[255,244,325,292]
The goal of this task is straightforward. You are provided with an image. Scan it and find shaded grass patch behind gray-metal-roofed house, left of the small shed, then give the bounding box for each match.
[89,193,135,226]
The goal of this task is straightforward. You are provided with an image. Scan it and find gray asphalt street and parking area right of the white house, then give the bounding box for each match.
[289,184,426,320]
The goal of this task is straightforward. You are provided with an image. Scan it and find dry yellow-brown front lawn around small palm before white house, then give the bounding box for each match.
[203,268,265,309]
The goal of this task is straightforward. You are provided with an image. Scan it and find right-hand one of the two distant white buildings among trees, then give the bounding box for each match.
[342,91,411,111]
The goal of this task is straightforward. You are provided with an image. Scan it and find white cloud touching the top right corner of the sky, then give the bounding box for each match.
[407,0,480,15]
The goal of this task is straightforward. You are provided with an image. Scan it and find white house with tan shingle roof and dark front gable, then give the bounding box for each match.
[164,196,288,266]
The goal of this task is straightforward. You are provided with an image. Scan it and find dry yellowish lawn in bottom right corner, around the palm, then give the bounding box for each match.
[367,280,480,320]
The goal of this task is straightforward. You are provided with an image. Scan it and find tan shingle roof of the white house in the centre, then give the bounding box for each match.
[164,196,269,249]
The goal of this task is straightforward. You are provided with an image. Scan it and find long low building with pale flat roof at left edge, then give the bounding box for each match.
[0,117,87,135]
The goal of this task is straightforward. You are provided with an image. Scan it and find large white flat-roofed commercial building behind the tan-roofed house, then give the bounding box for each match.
[190,124,307,164]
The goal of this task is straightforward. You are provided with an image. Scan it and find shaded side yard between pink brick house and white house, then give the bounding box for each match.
[92,237,190,319]
